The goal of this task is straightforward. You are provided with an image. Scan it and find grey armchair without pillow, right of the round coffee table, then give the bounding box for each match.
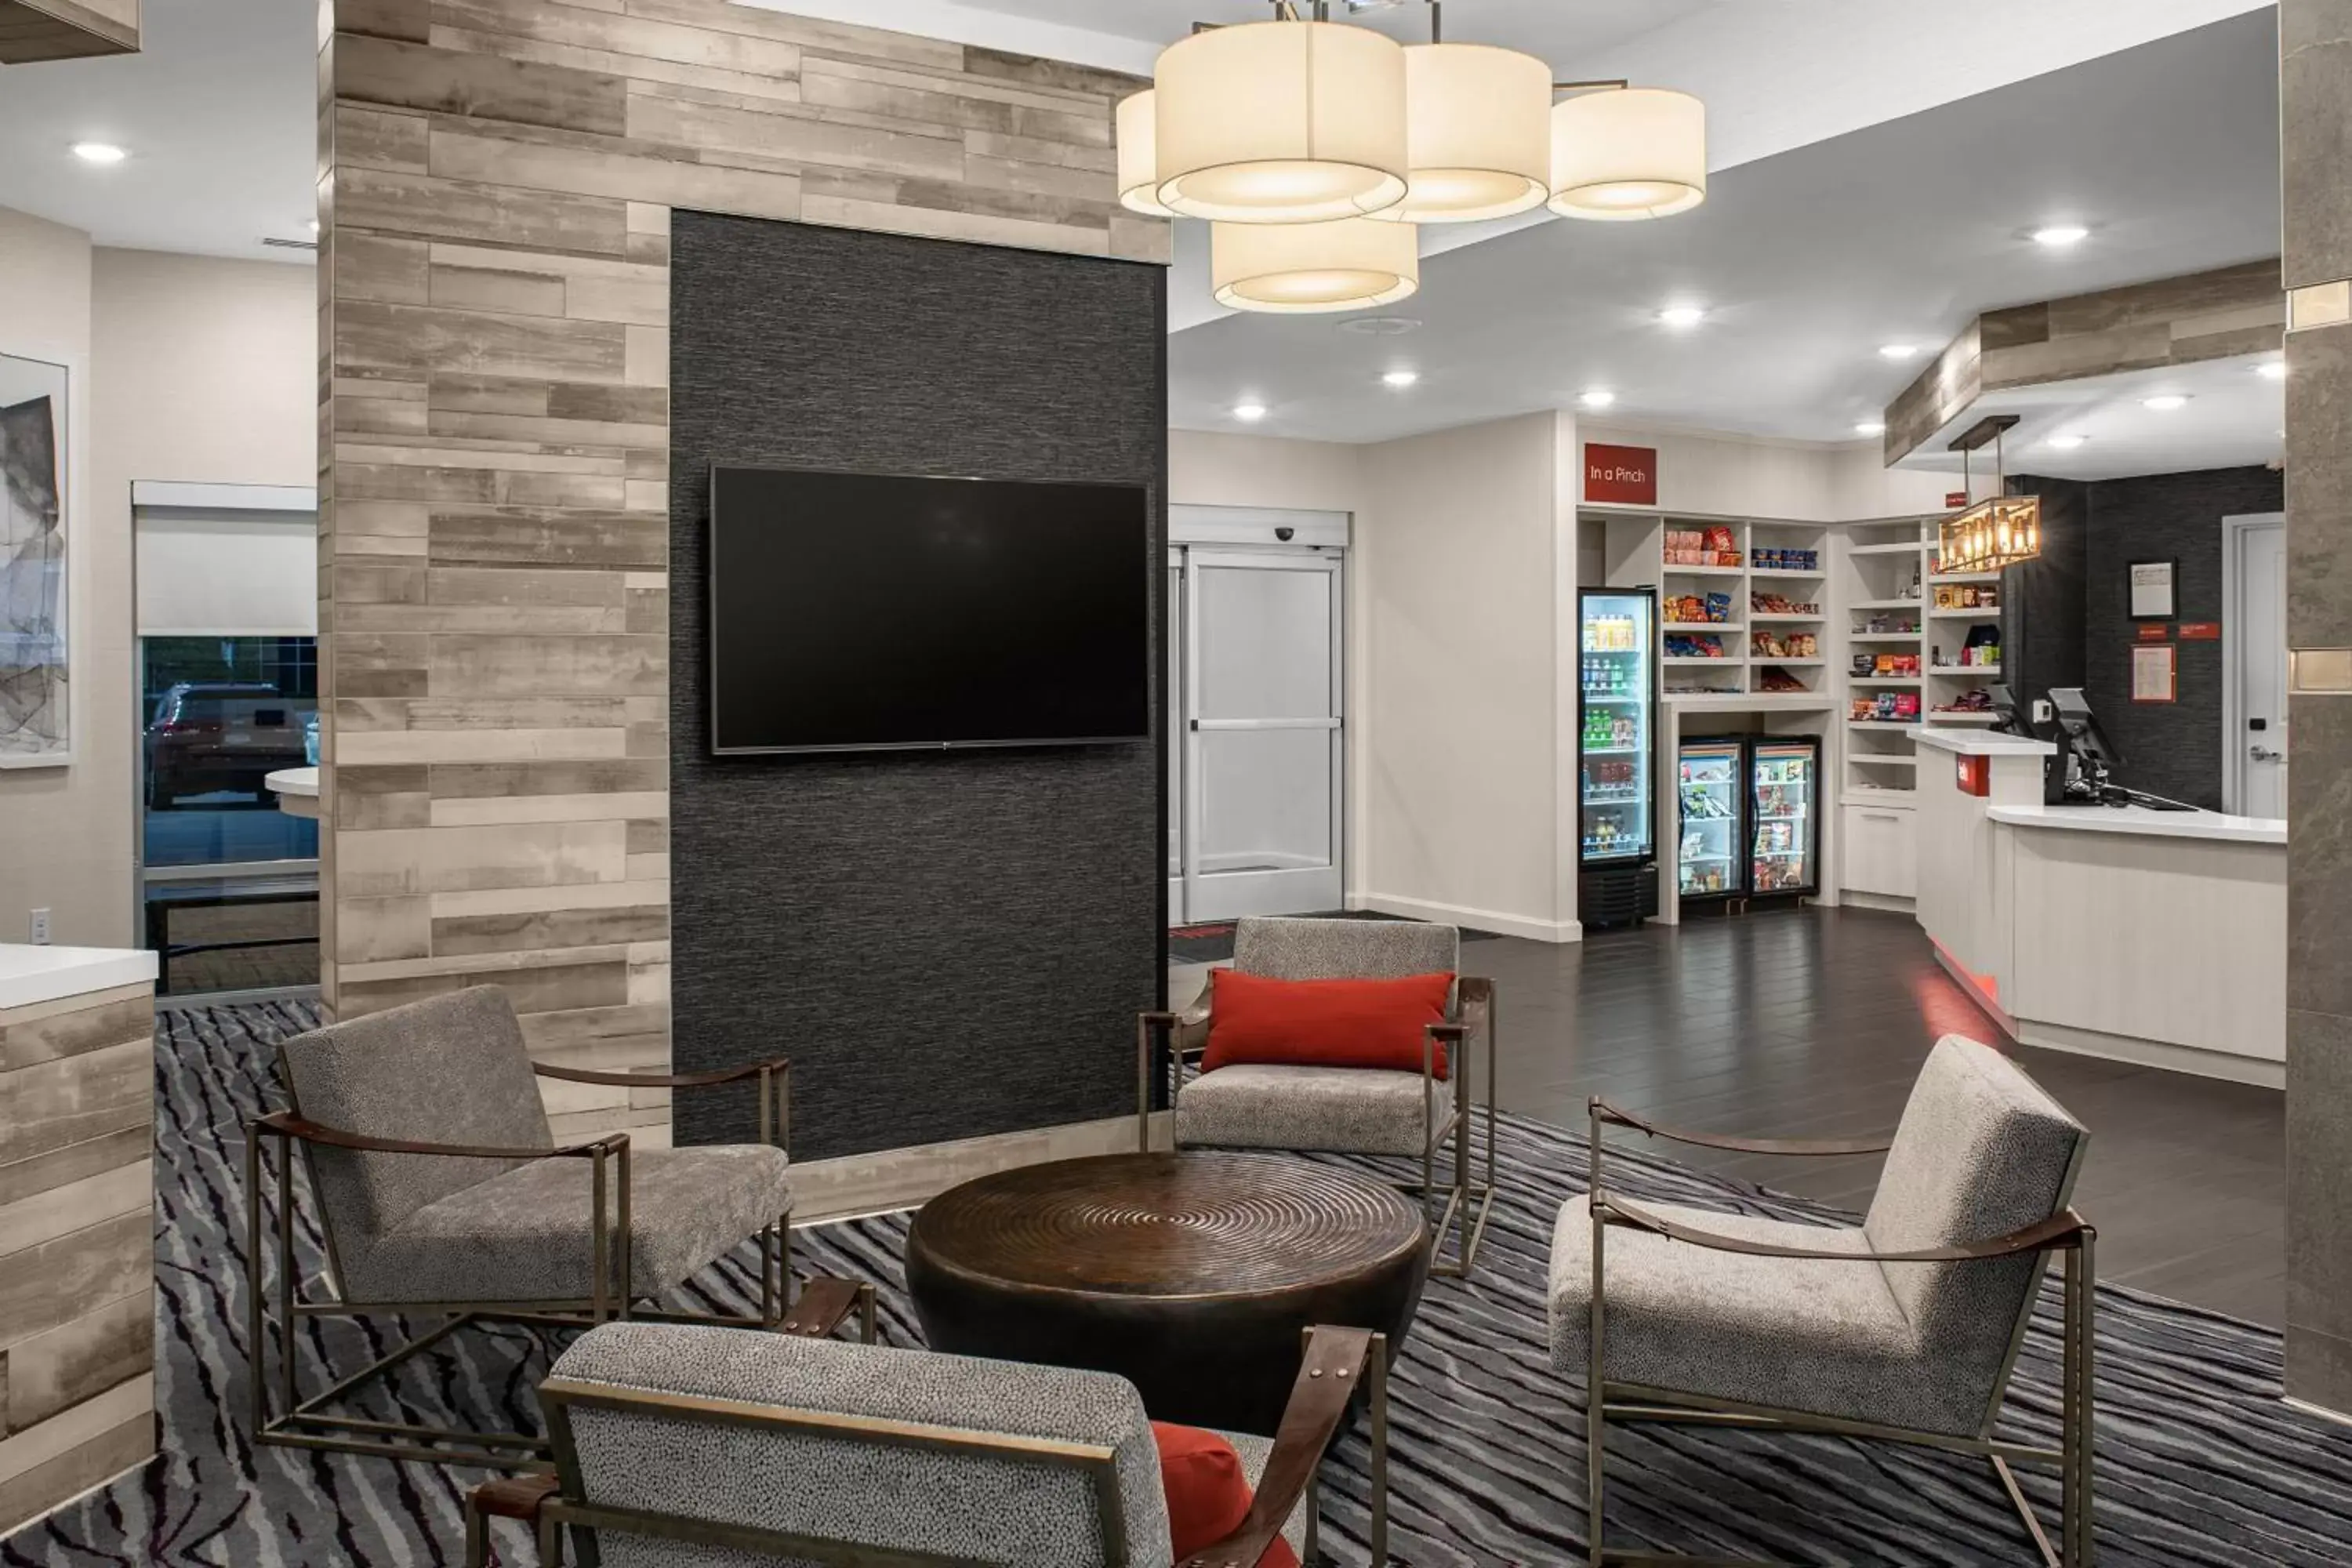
[1550,1034,2093,1568]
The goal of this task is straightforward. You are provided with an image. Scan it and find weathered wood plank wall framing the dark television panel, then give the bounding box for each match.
[320,0,1169,1138]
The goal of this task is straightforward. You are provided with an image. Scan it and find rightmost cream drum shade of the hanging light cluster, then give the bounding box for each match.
[1552,87,1708,223]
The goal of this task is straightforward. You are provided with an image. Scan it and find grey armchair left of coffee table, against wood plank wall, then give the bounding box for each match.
[245,987,793,1469]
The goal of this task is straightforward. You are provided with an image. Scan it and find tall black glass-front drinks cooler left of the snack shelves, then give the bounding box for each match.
[1576,588,1658,926]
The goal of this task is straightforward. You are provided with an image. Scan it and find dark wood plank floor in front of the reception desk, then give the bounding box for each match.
[1188,907,2286,1326]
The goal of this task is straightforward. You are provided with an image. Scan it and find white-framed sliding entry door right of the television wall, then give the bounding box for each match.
[1169,548,1343,924]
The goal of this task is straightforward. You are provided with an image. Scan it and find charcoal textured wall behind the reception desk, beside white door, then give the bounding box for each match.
[2084,468,2286,811]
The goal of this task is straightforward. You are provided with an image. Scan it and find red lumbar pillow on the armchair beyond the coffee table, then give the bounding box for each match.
[1200,968,1454,1076]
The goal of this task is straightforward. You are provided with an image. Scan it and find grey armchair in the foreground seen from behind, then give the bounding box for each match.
[466,1281,1388,1568]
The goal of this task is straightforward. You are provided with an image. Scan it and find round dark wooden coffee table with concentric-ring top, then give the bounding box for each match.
[906,1152,1430,1436]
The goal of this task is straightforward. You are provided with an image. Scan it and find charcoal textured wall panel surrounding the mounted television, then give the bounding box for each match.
[670,212,1167,1159]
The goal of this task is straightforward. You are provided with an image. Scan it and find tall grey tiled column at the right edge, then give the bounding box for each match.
[2279,0,2352,1413]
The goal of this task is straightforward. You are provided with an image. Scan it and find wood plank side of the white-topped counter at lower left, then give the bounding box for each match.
[0,985,155,1535]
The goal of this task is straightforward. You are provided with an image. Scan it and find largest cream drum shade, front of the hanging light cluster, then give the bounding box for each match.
[1152,21,1406,223]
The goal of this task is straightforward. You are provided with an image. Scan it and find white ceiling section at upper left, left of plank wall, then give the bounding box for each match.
[0,0,318,261]
